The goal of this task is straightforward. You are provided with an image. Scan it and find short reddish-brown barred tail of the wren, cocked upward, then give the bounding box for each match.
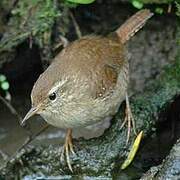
[116,9,153,44]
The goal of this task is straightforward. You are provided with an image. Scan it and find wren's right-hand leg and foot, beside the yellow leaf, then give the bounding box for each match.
[120,93,136,144]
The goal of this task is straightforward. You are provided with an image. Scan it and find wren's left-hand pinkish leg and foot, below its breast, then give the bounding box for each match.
[61,129,75,172]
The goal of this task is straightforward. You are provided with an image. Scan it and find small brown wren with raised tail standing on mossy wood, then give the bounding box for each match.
[22,9,153,171]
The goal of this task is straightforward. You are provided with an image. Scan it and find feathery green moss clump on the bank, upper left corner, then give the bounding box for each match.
[0,0,58,52]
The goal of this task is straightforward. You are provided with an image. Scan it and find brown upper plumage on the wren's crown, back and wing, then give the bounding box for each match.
[32,36,127,105]
